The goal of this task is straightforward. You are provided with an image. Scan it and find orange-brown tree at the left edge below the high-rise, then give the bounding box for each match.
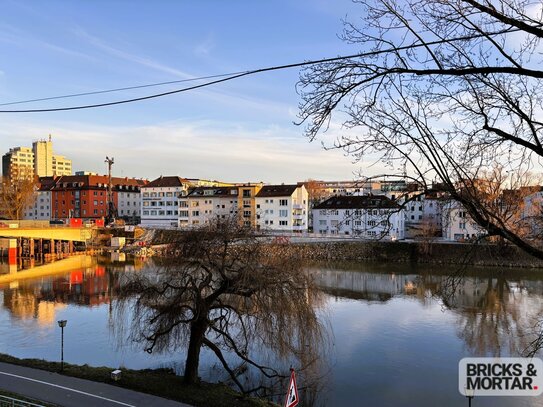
[0,176,36,219]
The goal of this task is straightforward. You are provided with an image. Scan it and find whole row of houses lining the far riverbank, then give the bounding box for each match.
[19,174,543,240]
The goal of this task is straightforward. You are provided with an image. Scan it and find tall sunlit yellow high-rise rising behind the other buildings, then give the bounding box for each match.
[2,136,72,179]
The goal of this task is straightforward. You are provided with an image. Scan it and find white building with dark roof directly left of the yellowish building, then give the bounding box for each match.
[179,187,238,227]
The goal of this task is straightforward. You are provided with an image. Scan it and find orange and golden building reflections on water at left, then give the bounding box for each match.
[3,266,118,324]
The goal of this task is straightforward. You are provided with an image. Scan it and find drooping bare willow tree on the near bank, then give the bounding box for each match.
[120,218,322,392]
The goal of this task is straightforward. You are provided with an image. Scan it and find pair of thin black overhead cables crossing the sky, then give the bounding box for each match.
[0,28,520,113]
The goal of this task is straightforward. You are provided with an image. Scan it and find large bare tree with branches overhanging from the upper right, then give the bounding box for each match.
[299,0,543,259]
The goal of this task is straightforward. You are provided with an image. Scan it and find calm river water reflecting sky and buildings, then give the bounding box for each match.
[0,257,543,407]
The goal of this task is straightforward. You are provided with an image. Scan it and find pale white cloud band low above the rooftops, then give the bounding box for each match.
[0,117,379,182]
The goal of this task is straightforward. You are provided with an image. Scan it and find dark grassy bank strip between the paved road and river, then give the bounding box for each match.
[0,354,276,407]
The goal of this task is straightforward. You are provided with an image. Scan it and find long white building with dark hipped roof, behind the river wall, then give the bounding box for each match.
[313,195,404,240]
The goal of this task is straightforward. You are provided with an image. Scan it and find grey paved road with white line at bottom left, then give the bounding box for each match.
[0,362,190,407]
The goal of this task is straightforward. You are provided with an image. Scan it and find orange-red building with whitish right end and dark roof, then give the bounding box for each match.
[51,175,147,219]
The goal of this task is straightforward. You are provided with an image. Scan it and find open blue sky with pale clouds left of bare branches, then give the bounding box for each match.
[0,0,379,183]
